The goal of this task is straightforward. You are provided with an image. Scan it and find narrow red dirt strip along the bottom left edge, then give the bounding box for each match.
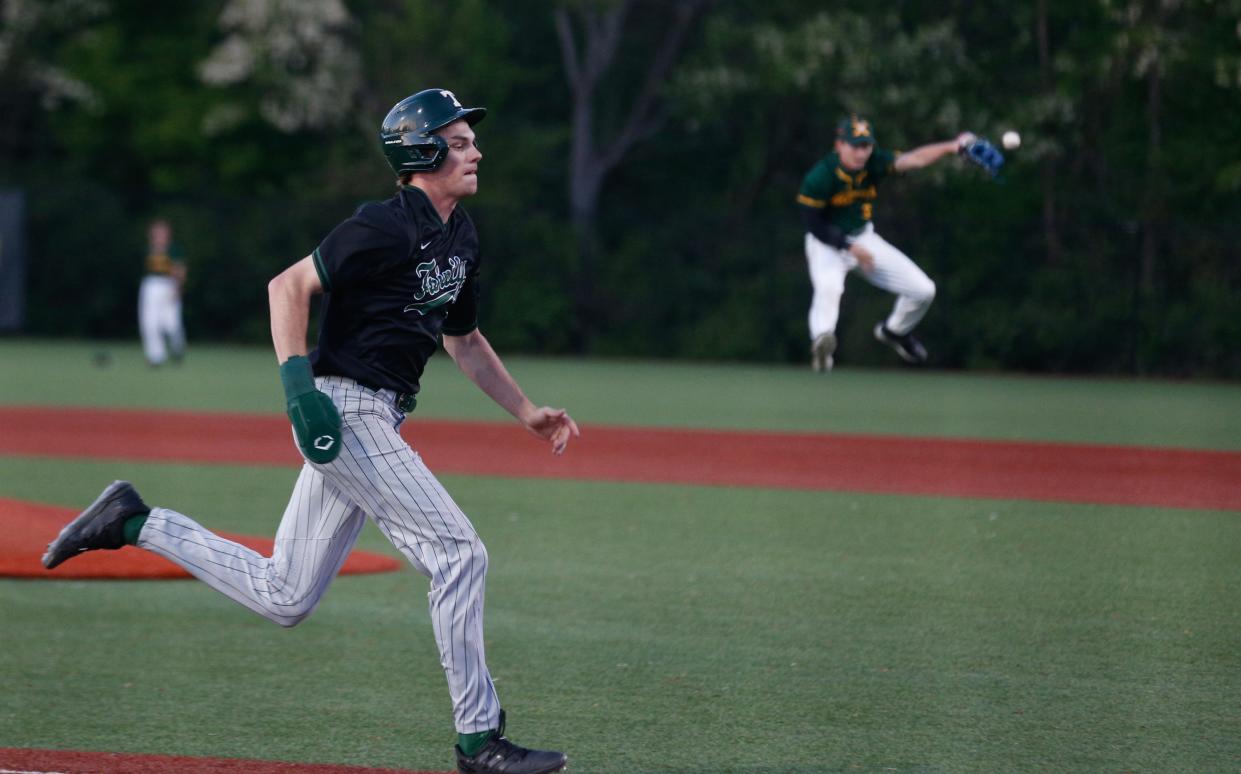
[0,747,446,774]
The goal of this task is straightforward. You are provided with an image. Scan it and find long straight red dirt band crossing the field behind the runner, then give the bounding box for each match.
[0,407,1241,510]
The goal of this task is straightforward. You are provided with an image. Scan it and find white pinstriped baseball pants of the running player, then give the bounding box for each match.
[138,376,500,733]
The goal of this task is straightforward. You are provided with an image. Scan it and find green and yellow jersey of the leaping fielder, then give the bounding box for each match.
[797,148,898,236]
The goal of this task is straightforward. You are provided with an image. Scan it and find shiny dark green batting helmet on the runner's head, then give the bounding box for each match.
[380,89,486,175]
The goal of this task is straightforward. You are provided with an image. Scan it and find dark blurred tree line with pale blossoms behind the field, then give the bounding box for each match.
[0,0,1241,378]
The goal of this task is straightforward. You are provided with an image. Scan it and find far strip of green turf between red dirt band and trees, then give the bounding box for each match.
[0,340,1241,449]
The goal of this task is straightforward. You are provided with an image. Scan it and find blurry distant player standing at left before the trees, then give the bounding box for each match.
[138,214,185,366]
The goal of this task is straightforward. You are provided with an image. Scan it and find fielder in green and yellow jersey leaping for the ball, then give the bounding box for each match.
[797,115,975,372]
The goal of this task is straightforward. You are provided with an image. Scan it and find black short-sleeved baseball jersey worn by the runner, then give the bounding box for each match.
[310,186,479,393]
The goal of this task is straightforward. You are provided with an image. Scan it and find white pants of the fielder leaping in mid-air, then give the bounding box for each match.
[805,223,934,341]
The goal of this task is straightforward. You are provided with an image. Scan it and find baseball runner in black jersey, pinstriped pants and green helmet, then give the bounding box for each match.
[43,89,578,774]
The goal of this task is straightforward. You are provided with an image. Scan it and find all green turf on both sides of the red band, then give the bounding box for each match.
[0,341,1241,774]
